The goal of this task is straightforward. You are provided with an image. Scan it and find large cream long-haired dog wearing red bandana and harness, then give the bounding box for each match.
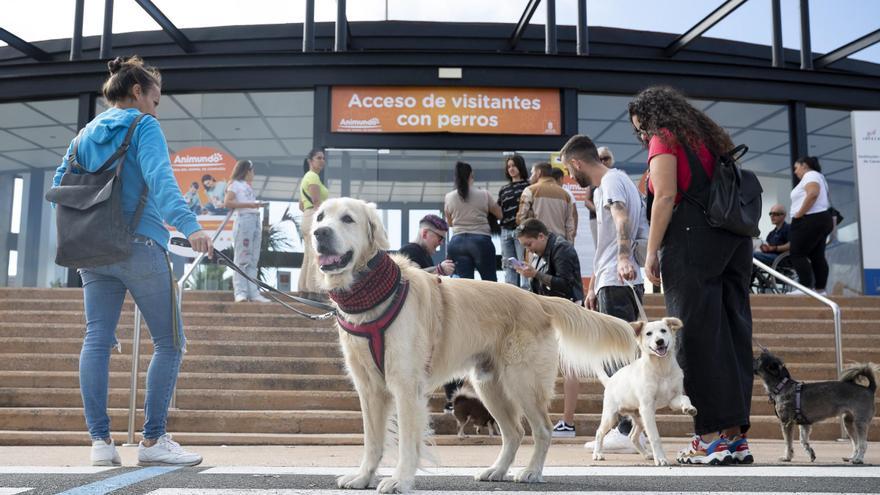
[309,198,638,493]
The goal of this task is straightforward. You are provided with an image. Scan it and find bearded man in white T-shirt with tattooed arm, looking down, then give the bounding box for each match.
[560,135,648,453]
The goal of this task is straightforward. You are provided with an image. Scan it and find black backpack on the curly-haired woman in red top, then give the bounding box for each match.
[679,139,764,237]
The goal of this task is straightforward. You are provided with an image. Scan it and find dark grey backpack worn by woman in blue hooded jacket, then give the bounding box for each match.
[46,114,147,268]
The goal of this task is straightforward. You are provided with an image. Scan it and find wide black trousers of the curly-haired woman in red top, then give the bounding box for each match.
[660,200,754,435]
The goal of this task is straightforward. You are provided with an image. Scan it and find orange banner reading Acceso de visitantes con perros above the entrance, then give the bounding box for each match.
[331,86,561,136]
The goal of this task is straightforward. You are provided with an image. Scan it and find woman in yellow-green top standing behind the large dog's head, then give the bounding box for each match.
[299,149,327,300]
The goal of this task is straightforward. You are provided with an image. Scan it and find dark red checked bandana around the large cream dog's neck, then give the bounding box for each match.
[328,251,400,315]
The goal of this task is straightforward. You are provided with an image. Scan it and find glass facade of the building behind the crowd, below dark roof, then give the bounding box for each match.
[0,90,862,294]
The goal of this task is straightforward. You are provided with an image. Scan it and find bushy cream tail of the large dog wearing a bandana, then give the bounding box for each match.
[540,297,639,384]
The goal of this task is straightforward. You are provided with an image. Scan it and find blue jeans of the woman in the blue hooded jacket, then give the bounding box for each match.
[79,236,185,440]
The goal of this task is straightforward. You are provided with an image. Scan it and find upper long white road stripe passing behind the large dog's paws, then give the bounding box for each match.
[201,466,880,478]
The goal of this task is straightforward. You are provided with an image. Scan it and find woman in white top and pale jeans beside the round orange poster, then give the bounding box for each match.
[224,160,269,302]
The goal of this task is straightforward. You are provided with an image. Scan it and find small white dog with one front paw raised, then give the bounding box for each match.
[593,318,697,466]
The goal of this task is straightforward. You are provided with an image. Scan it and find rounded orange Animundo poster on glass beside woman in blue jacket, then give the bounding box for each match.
[168,146,237,257]
